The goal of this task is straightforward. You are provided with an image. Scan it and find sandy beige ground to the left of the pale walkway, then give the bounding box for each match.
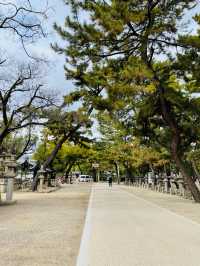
[0,184,91,266]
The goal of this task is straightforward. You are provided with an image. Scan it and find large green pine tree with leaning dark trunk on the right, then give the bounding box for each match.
[55,0,200,202]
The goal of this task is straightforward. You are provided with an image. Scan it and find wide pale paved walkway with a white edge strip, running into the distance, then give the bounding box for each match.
[77,184,200,266]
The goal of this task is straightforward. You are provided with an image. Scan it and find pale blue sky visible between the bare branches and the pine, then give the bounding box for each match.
[0,0,200,101]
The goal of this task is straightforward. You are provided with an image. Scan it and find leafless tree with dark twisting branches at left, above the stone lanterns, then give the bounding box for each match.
[0,62,54,150]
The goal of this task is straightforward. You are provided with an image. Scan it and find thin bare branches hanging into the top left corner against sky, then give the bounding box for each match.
[0,0,49,60]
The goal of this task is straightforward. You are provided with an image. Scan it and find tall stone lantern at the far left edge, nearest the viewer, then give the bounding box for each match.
[0,153,17,202]
